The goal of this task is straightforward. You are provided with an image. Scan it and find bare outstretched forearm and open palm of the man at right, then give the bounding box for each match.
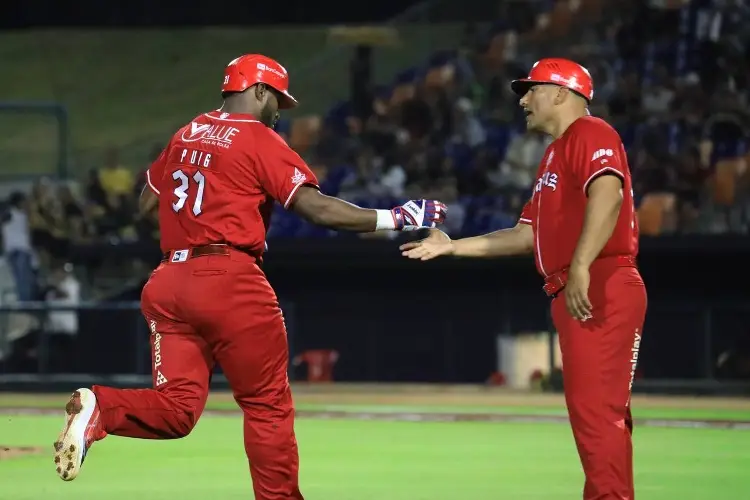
[400,223,534,260]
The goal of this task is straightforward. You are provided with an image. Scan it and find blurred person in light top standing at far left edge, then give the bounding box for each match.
[2,192,35,302]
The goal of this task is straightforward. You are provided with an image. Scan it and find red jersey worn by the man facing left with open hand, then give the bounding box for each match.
[519,116,638,277]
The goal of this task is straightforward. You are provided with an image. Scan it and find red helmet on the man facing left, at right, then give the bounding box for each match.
[510,58,594,102]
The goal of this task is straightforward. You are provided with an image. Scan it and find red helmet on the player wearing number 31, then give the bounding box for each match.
[221,54,297,109]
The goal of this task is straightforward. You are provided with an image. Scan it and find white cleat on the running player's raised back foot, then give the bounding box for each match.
[55,389,106,481]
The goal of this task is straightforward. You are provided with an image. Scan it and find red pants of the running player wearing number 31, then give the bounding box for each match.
[93,250,303,500]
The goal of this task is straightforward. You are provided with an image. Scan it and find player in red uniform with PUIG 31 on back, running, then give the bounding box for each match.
[55,54,446,500]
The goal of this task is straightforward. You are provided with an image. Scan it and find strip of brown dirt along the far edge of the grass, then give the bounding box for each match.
[0,384,750,430]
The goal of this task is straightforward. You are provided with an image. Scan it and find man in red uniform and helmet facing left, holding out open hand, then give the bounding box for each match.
[401,59,646,500]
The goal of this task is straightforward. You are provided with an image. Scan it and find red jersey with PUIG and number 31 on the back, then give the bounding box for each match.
[146,111,318,255]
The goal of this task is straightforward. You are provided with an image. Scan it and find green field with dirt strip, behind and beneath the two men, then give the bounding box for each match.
[0,390,750,500]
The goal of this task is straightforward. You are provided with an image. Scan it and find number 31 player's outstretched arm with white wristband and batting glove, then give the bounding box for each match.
[291,186,446,233]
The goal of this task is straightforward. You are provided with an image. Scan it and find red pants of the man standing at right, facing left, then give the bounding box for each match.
[552,266,646,500]
